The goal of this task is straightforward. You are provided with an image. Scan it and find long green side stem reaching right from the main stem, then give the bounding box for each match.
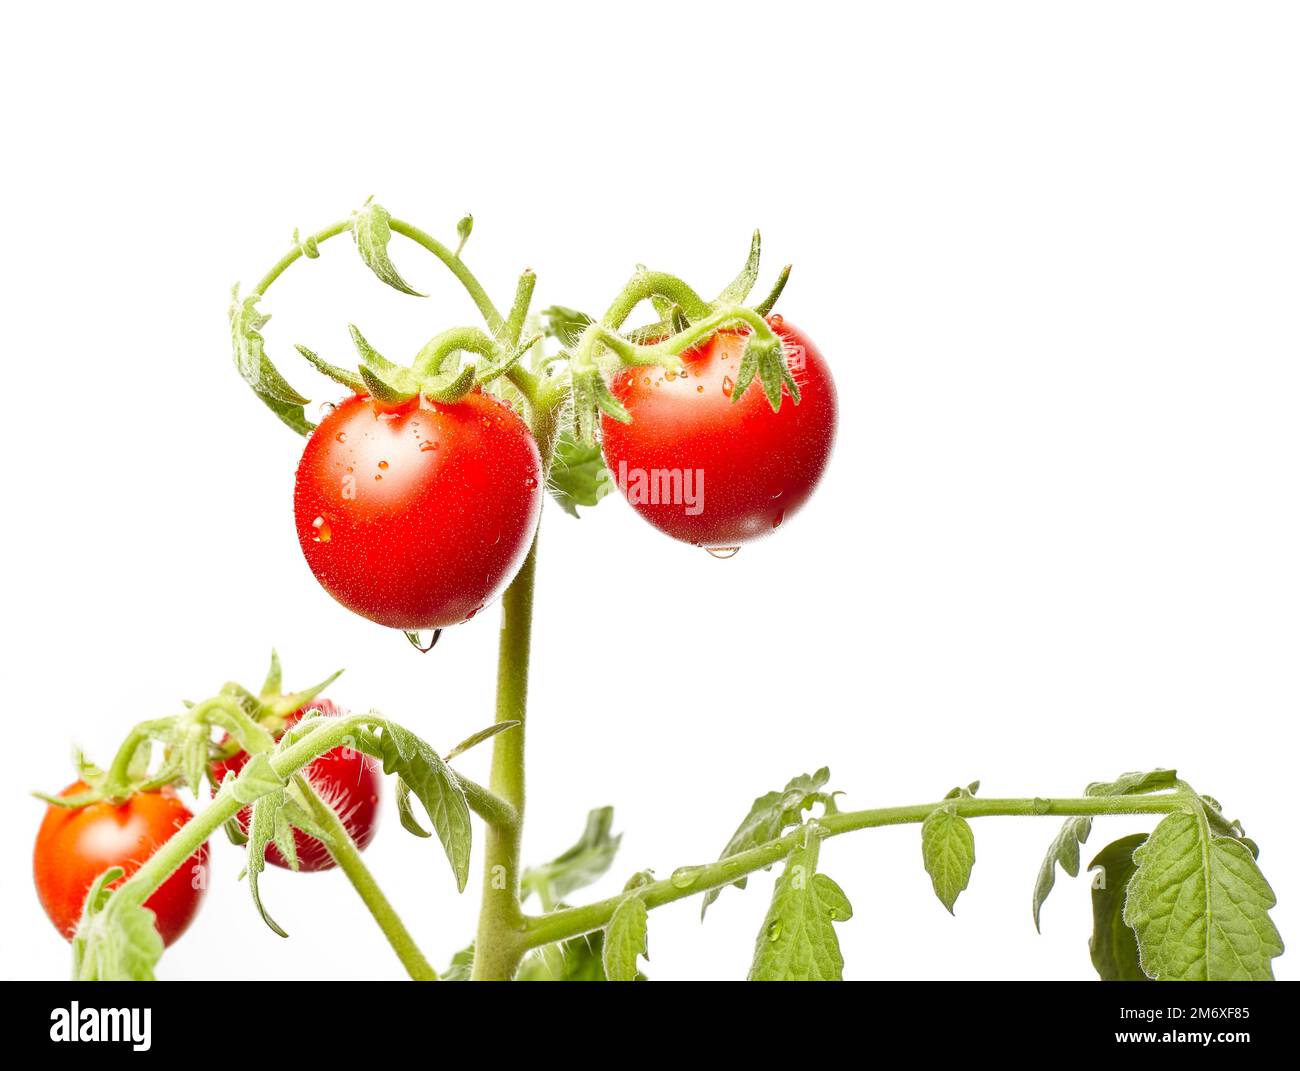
[524,793,1187,949]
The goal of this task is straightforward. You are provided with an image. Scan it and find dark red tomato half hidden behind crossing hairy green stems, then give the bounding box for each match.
[213,699,384,871]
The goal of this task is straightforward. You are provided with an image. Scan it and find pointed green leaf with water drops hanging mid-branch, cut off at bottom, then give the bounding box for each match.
[749,827,853,981]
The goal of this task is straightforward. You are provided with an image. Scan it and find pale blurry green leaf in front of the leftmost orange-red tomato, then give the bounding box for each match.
[73,867,163,981]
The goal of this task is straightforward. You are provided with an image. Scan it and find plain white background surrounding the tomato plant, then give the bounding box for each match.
[0,3,1300,979]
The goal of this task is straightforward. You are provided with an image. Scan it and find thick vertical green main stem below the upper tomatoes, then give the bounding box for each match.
[473,536,537,981]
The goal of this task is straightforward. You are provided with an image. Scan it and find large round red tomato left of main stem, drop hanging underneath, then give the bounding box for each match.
[294,391,542,630]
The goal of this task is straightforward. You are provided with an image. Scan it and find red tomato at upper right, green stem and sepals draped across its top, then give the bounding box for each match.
[602,316,837,550]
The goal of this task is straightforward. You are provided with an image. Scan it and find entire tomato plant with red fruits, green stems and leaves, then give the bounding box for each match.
[38,203,1282,981]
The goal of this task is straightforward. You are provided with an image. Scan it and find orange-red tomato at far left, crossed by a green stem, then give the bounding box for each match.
[33,781,208,945]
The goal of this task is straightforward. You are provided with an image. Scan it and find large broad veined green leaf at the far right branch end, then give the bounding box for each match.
[1123,805,1282,981]
